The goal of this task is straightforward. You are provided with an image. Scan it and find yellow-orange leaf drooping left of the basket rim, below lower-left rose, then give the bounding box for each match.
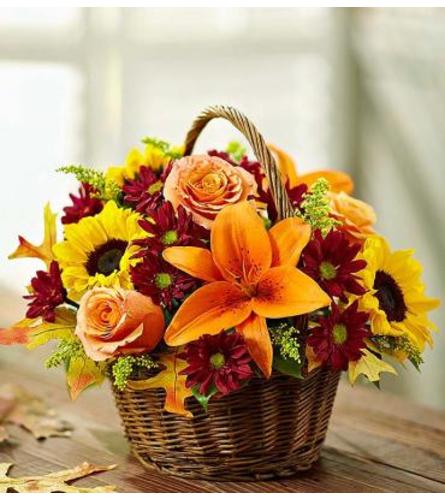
[66,355,105,400]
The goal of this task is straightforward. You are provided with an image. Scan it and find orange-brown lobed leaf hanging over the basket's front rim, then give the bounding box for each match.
[128,353,193,417]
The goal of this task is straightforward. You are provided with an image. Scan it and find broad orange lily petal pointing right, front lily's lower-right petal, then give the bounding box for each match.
[252,266,331,318]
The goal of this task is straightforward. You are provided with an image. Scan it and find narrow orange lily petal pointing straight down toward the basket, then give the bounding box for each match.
[236,313,273,378]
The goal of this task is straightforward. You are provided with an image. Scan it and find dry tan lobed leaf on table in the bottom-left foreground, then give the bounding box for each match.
[0,462,116,493]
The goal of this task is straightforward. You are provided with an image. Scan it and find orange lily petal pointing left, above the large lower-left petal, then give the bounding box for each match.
[162,246,222,281]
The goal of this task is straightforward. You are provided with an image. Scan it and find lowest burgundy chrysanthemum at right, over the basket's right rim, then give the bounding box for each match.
[307,301,370,370]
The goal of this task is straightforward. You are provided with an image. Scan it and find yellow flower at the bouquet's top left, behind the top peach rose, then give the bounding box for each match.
[105,143,182,187]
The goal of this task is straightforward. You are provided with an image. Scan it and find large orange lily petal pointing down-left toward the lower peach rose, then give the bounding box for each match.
[165,281,252,346]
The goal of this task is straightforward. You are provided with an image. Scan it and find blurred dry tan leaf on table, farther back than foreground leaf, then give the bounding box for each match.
[0,384,72,442]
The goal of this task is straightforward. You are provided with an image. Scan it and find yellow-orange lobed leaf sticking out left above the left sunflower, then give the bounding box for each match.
[8,203,57,267]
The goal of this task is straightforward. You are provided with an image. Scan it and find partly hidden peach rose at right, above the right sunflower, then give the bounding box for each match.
[329,191,377,240]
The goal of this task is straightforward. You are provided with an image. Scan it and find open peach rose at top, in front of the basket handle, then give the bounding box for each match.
[164,155,257,229]
